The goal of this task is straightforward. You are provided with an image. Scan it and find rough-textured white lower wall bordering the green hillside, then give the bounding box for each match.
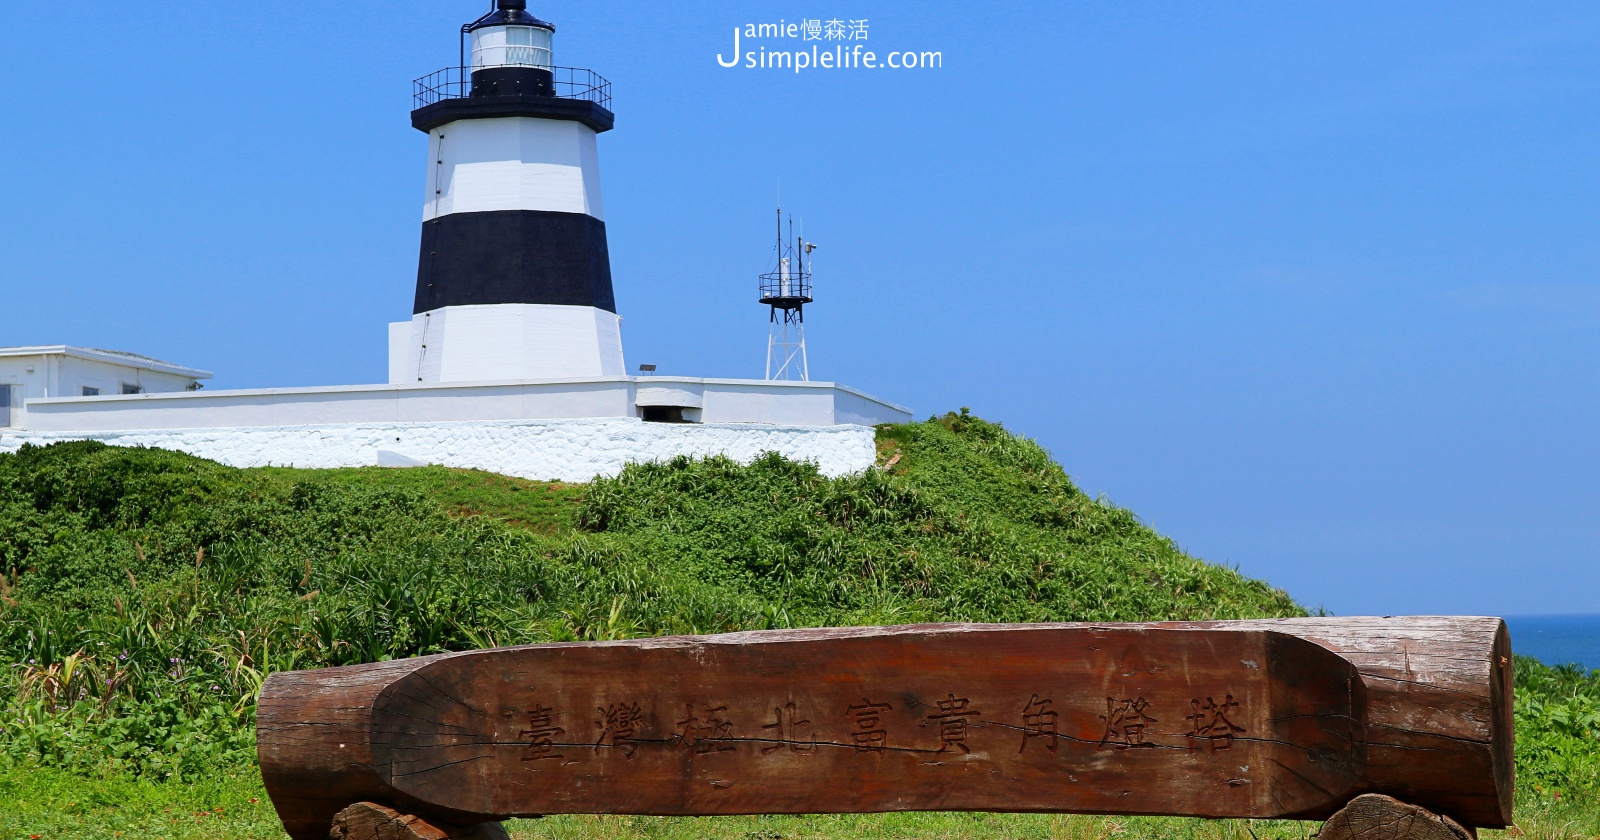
[0,418,877,482]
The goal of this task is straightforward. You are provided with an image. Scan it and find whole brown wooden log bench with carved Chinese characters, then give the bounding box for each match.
[258,618,1512,840]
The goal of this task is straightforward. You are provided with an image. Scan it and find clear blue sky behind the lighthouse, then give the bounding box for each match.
[0,0,1600,614]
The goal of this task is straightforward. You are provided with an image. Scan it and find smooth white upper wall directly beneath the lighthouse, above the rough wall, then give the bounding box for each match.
[12,376,910,432]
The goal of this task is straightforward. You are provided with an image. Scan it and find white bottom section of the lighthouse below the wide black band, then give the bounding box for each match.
[389,304,627,386]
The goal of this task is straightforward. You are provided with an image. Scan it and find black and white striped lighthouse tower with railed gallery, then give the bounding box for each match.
[389,0,624,384]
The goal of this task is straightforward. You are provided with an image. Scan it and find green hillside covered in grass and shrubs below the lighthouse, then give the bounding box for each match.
[0,411,1600,840]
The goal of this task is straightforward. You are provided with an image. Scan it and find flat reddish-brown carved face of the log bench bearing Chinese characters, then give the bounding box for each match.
[360,626,1363,816]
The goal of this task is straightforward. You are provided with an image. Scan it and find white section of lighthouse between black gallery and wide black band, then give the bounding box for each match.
[422,117,605,221]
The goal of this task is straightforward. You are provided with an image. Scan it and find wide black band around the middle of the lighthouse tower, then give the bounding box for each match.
[411,210,616,314]
